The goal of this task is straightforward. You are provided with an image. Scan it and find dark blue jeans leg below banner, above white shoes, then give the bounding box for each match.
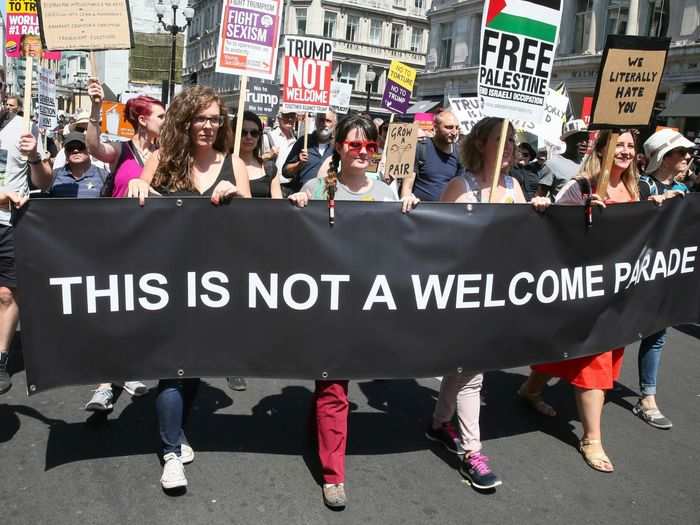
[156,379,199,456]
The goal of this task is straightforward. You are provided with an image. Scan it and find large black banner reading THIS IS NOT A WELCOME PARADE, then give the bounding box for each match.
[10,195,700,391]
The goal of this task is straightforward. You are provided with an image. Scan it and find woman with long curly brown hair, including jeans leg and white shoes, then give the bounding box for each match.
[128,86,250,490]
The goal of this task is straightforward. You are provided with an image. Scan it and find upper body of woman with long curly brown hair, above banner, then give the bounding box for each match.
[128,86,250,206]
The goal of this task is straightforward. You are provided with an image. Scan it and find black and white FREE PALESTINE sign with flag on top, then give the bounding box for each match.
[479,0,561,122]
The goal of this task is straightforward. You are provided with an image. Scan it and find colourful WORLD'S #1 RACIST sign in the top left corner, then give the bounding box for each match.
[5,0,61,60]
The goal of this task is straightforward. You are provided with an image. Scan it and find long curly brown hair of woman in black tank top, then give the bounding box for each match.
[153,86,233,191]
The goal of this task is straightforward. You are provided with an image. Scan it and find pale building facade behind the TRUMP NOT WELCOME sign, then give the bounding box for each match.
[184,0,430,114]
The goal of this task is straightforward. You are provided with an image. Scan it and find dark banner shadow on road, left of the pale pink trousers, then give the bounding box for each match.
[46,374,436,472]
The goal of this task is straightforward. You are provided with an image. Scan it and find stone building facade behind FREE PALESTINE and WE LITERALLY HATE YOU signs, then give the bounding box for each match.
[417,0,700,136]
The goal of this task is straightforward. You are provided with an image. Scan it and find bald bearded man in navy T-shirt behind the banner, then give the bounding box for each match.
[401,111,464,201]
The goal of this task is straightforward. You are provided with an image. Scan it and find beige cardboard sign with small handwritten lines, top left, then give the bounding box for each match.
[37,0,134,51]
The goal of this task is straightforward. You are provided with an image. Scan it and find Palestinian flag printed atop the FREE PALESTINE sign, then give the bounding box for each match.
[485,0,561,44]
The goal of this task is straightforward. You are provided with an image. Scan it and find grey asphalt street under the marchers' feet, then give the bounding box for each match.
[0,330,700,525]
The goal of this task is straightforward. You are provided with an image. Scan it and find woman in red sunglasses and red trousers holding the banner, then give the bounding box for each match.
[289,115,420,509]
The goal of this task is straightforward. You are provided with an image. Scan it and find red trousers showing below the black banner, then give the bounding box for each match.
[316,381,350,483]
